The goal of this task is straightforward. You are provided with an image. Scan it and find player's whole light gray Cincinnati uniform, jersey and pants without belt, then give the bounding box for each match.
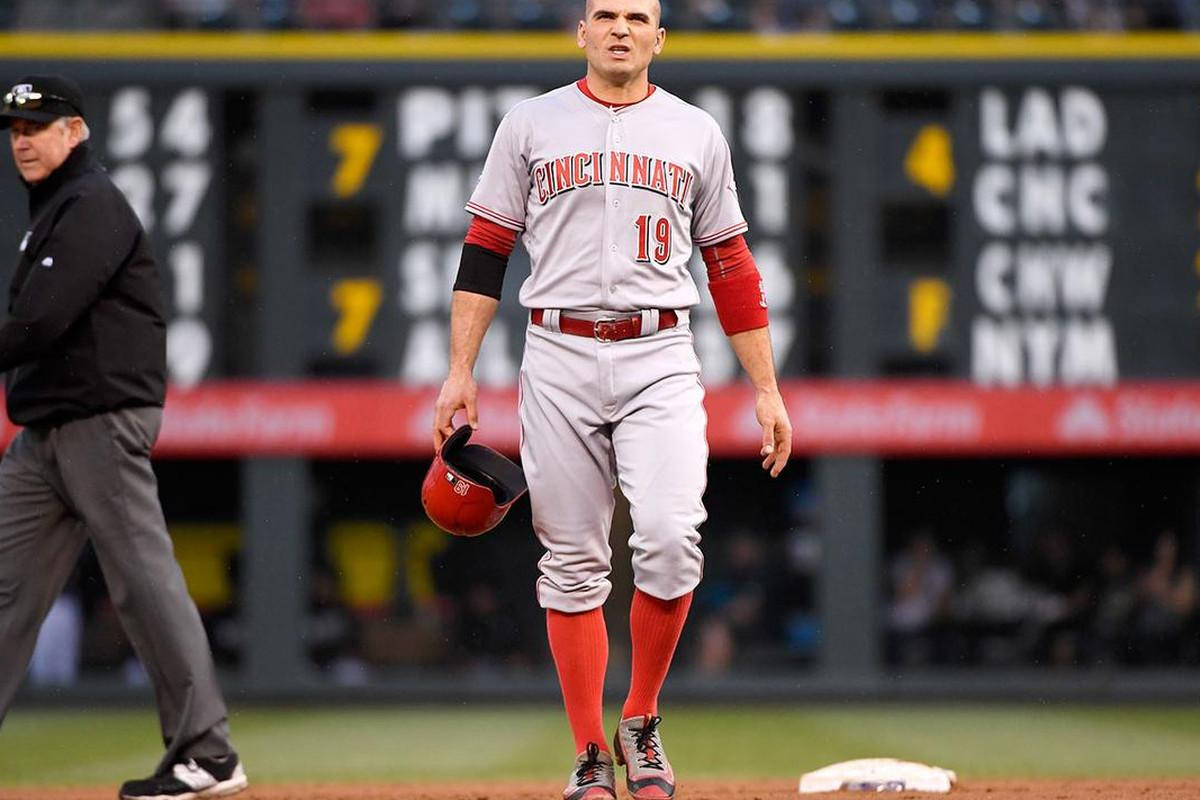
[467,82,746,612]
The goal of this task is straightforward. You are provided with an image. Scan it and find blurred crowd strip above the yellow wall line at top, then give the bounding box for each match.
[7,0,1200,32]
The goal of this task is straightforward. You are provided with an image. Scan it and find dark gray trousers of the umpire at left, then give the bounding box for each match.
[0,407,230,768]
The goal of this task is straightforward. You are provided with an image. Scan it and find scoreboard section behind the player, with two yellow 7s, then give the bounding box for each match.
[286,84,803,385]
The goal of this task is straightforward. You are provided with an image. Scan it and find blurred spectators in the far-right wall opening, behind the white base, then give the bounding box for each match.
[887,528,1200,668]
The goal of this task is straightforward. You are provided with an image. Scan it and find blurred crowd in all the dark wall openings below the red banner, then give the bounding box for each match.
[31,463,1200,685]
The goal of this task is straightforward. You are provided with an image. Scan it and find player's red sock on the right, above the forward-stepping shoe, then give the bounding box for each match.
[620,589,691,720]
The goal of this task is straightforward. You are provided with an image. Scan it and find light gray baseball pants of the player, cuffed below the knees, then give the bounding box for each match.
[520,312,708,613]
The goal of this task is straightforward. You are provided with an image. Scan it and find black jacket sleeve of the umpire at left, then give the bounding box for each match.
[0,193,137,372]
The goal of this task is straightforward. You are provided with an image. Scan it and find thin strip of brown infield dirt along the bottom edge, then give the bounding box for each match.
[7,777,1200,800]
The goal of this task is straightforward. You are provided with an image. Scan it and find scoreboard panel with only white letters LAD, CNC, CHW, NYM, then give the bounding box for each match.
[958,84,1200,386]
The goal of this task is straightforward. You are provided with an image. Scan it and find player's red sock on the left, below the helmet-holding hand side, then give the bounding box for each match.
[546,608,608,753]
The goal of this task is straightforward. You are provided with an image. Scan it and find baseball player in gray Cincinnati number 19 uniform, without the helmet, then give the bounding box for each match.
[433,0,792,800]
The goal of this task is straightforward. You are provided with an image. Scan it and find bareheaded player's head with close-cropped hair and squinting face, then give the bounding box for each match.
[577,0,667,83]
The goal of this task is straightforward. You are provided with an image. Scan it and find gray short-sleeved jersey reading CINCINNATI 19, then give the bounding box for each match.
[467,84,746,311]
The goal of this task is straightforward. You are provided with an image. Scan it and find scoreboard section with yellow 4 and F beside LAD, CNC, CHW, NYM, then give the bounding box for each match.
[874,83,1200,386]
